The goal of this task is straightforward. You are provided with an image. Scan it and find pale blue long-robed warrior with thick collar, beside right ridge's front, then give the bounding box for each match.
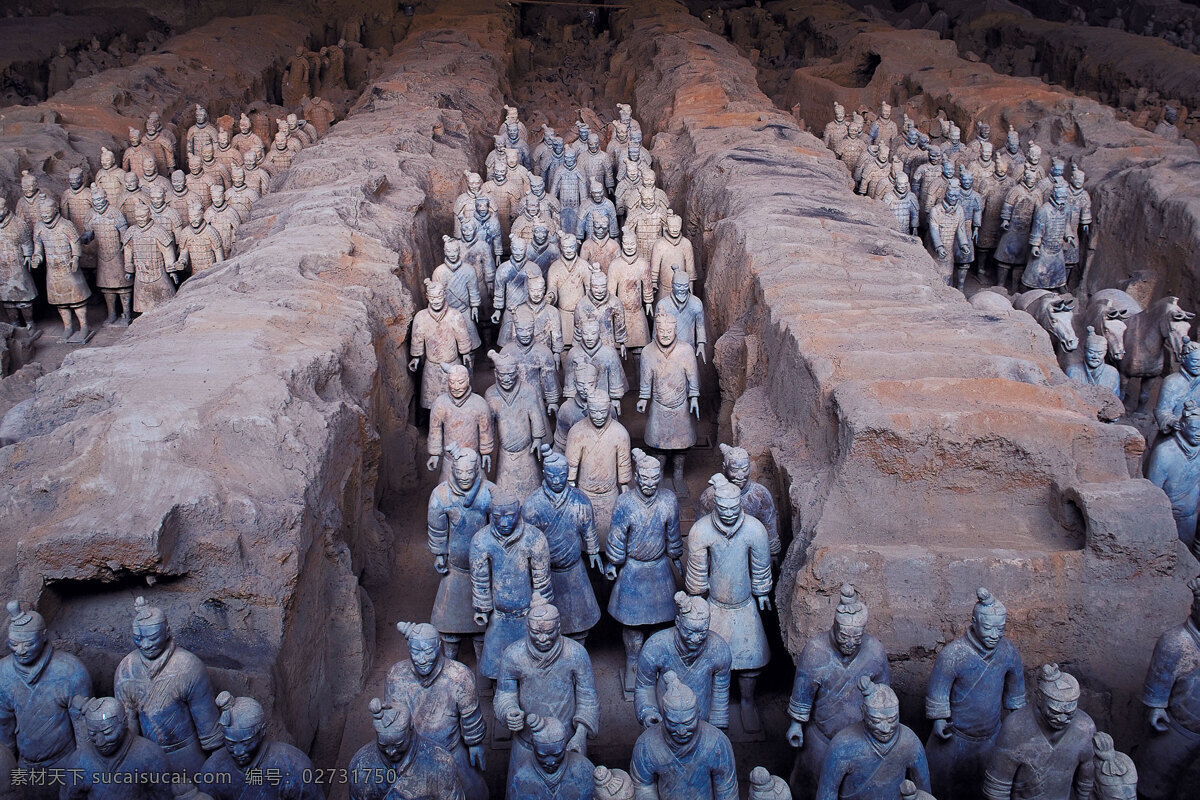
[685,475,772,732]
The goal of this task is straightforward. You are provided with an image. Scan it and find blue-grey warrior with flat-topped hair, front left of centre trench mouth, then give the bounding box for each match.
[384,623,487,800]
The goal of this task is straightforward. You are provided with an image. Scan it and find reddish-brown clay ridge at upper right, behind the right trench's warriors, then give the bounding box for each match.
[774,0,1200,326]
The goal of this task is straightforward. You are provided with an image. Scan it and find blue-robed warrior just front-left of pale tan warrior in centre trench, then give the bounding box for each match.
[521,445,602,642]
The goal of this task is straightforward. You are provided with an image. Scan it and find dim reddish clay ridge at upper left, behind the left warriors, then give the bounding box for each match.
[0,14,308,197]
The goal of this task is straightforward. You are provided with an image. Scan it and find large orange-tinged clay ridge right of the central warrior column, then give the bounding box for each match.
[613,0,1186,732]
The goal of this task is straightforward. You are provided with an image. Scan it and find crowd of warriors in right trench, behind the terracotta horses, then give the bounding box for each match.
[824,103,1092,291]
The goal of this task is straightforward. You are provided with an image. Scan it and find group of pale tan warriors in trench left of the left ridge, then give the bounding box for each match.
[0,106,317,343]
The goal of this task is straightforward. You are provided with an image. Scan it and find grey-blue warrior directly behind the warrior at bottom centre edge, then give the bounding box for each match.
[494,597,600,772]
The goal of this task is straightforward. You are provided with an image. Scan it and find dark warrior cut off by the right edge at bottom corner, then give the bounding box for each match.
[1132,577,1200,800]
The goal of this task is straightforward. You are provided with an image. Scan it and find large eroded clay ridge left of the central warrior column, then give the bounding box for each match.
[0,0,514,747]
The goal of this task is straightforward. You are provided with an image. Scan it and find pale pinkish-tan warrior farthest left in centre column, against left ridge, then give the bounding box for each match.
[408,279,473,408]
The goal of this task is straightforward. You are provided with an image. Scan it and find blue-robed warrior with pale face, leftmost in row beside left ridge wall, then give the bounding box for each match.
[426,444,496,658]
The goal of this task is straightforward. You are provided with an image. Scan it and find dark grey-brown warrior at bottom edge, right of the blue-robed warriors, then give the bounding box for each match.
[983,664,1096,800]
